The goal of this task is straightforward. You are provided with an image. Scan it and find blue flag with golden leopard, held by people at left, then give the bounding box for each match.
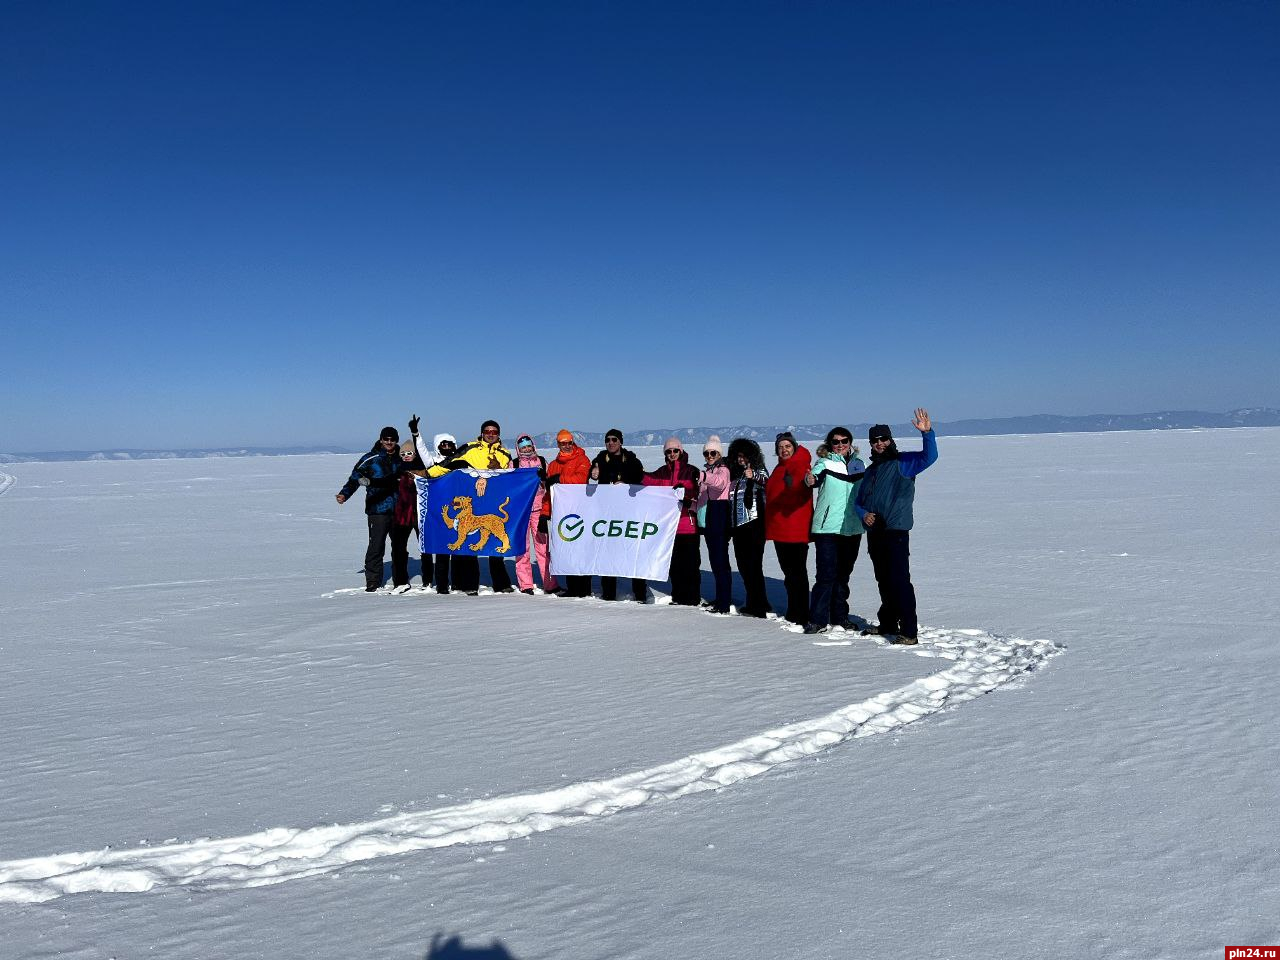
[417,470,539,557]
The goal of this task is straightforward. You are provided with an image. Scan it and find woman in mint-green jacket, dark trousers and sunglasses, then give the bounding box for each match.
[804,426,865,634]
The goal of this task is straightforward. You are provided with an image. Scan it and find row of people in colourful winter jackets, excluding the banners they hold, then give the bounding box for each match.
[337,407,938,644]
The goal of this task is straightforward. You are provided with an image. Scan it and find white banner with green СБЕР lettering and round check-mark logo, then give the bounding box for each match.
[547,484,681,580]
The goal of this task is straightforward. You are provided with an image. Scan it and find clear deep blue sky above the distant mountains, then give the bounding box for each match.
[0,0,1280,451]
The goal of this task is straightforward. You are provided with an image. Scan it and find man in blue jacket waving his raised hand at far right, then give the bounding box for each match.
[854,407,938,644]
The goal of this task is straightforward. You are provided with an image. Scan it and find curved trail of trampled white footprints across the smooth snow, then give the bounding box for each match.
[0,630,1061,902]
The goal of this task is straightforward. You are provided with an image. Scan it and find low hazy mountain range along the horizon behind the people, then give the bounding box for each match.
[0,407,1280,463]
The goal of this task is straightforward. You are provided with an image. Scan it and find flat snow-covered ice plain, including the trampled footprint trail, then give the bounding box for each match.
[0,429,1280,960]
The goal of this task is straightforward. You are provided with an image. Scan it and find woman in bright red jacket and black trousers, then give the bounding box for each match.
[764,433,813,626]
